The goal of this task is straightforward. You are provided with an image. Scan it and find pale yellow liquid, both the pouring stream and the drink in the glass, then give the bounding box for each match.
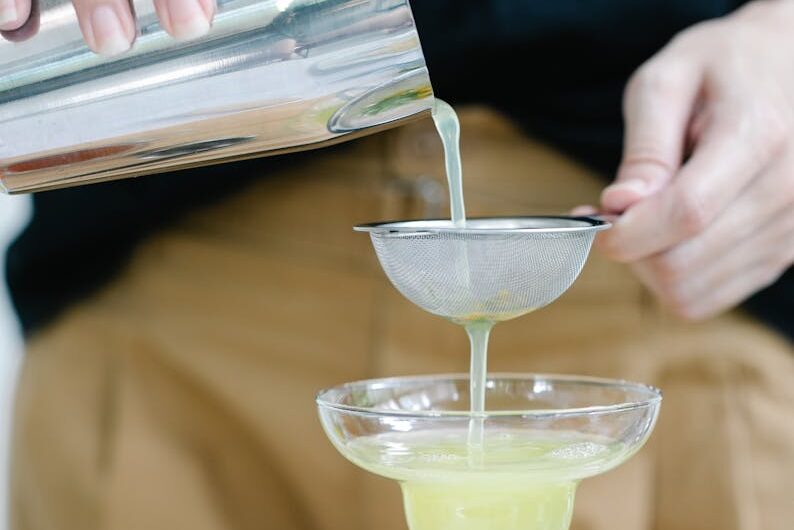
[358,99,580,530]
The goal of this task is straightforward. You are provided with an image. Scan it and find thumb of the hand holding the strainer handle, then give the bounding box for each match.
[601,57,700,213]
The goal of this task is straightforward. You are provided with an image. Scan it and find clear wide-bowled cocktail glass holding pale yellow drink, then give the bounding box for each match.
[317,374,661,530]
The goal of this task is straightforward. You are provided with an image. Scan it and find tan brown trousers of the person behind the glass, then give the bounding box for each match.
[7,109,794,530]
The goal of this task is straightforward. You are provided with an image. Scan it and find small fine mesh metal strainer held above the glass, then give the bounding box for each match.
[355,217,609,322]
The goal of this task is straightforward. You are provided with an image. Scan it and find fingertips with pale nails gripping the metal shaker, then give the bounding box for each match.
[0,0,215,55]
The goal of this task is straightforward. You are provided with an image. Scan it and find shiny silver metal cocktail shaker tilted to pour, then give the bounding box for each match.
[0,0,433,193]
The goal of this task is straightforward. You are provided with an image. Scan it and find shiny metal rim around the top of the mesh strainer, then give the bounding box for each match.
[353,215,612,235]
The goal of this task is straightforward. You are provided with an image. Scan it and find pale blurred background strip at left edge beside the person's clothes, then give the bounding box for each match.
[0,194,31,530]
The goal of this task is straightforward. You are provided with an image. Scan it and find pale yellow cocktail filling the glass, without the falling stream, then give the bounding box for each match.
[347,430,624,530]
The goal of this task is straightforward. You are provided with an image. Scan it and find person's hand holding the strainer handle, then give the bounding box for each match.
[580,0,794,320]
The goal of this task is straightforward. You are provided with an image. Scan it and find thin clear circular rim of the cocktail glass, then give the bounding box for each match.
[315,372,662,420]
